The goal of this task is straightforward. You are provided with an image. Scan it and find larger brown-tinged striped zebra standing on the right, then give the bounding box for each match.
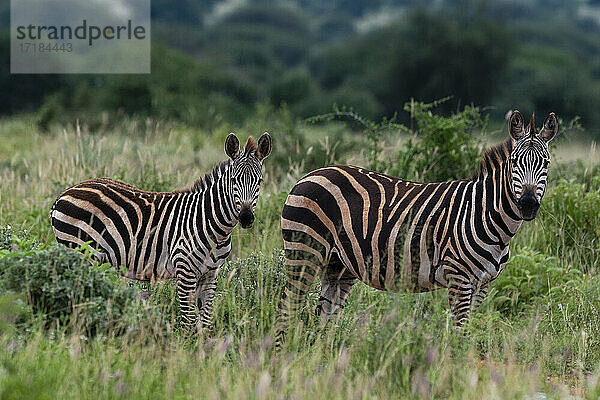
[276,110,558,346]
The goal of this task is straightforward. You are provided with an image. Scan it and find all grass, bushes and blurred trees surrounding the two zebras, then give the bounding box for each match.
[0,0,600,399]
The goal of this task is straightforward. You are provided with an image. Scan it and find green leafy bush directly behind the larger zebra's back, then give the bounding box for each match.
[309,99,487,182]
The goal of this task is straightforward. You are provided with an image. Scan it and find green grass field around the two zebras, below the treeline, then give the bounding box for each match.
[0,114,600,399]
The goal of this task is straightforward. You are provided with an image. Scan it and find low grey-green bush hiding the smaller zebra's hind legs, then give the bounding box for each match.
[0,245,136,334]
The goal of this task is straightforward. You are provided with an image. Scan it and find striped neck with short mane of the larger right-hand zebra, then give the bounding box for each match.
[473,140,522,244]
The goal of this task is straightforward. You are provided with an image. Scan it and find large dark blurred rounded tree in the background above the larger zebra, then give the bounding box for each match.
[379,11,513,113]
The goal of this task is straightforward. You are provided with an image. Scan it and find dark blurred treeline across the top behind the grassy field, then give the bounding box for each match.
[0,0,600,136]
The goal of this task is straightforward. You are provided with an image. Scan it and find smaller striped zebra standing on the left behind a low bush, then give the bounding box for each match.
[50,132,271,329]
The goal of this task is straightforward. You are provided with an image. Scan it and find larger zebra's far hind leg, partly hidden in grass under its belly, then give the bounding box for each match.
[315,254,356,328]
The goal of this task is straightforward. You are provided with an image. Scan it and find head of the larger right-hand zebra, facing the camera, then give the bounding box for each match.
[508,110,558,221]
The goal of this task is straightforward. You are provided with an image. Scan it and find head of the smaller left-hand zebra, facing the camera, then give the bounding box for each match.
[225,132,271,228]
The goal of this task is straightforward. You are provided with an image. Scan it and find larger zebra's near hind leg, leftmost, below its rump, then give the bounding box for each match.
[275,242,321,350]
